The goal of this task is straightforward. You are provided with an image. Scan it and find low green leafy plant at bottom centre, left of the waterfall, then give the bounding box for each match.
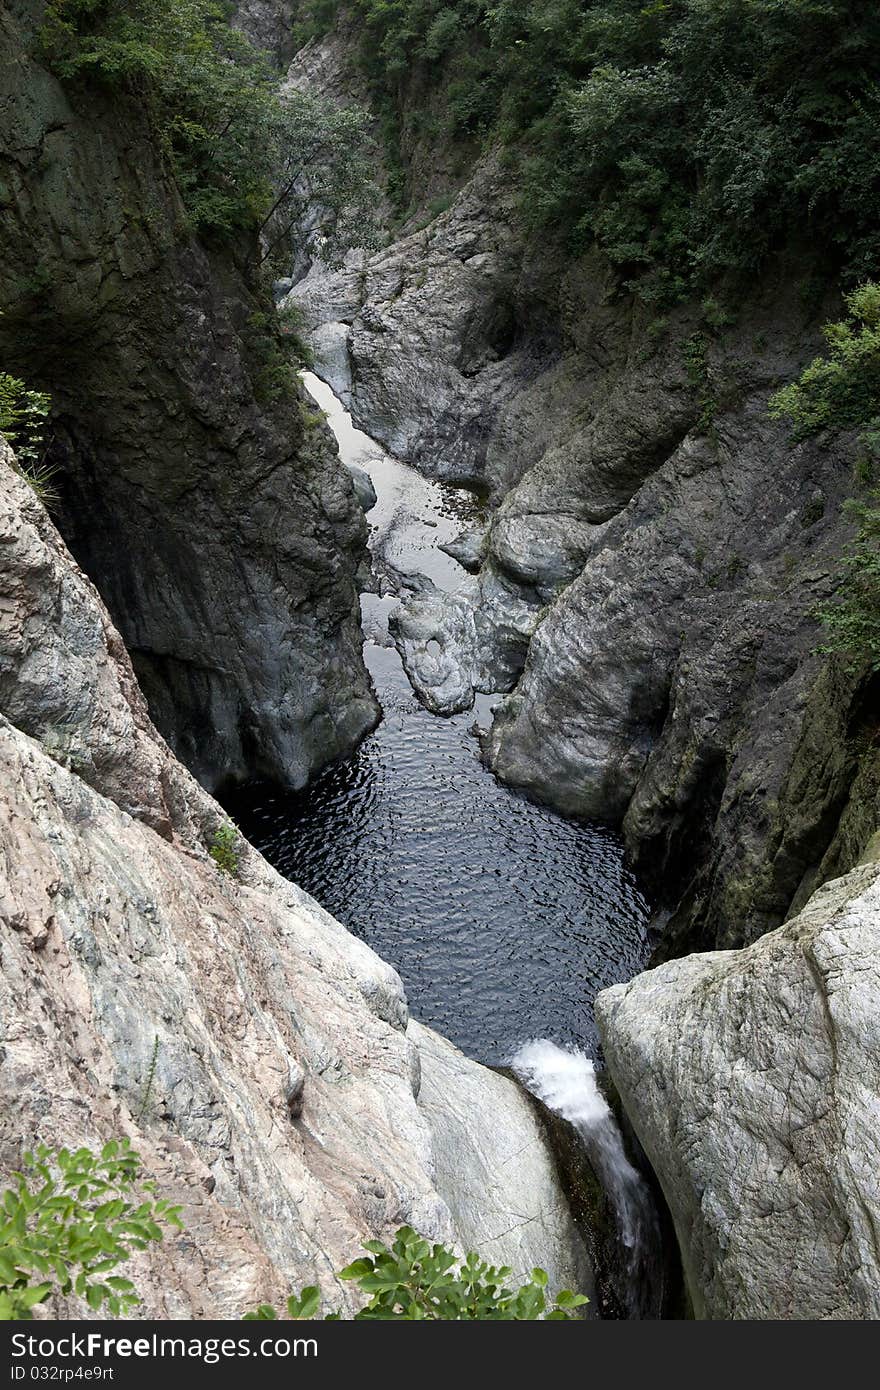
[245,1226,588,1322]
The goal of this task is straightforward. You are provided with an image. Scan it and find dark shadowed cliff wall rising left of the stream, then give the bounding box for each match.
[0,0,378,788]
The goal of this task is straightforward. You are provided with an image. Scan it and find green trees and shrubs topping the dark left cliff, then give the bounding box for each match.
[42,0,370,250]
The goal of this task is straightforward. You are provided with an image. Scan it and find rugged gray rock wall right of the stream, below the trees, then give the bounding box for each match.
[284,36,880,955]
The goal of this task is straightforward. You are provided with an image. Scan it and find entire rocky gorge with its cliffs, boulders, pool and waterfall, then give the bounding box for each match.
[0,0,880,1319]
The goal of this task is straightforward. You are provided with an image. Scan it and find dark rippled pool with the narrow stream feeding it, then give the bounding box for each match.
[229,382,646,1062]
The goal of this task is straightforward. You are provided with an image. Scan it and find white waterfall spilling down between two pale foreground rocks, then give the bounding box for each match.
[510,1038,662,1318]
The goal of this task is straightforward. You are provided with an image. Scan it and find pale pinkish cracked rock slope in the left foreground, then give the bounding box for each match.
[0,453,589,1318]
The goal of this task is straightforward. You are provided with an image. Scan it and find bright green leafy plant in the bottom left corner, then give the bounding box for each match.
[0,1138,181,1321]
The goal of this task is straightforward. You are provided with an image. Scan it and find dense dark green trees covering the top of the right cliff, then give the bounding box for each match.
[300,0,880,302]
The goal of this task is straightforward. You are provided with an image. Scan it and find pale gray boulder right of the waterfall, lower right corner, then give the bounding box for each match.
[596,863,880,1319]
